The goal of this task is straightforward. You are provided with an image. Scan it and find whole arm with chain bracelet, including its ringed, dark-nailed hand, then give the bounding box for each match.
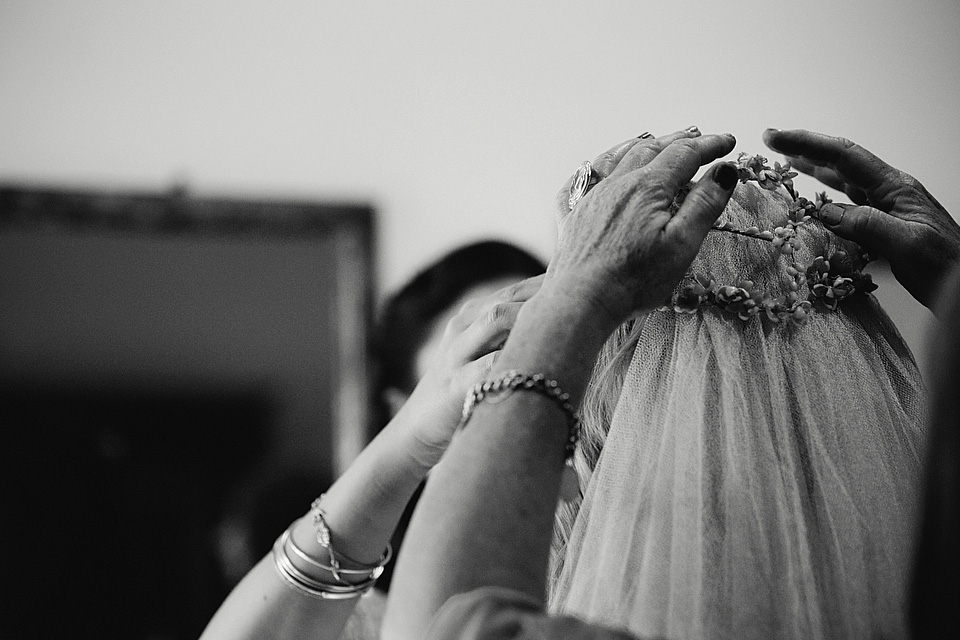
[383,135,736,640]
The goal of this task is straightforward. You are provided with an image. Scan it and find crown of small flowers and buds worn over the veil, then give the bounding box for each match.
[663,153,877,325]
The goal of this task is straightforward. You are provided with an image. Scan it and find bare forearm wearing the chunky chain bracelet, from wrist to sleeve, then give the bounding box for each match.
[384,290,616,638]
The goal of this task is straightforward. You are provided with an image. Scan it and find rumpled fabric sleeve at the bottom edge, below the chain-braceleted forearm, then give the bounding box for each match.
[427,587,637,640]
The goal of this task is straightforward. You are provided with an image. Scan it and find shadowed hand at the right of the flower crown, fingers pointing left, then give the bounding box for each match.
[763,129,960,307]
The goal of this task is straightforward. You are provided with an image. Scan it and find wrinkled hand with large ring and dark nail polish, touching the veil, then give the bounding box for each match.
[548,130,737,323]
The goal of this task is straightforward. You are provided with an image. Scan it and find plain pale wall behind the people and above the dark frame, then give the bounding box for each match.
[0,0,960,370]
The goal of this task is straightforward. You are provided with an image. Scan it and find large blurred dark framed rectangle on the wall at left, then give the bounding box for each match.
[0,186,373,640]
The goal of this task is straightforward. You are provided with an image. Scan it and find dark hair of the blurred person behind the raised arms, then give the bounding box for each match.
[374,240,546,592]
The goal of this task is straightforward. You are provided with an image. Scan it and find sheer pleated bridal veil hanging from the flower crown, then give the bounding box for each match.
[549,184,924,640]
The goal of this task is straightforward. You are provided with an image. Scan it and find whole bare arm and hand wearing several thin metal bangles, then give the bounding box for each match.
[201,276,543,640]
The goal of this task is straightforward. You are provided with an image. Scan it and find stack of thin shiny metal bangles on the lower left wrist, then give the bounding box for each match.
[273,496,393,600]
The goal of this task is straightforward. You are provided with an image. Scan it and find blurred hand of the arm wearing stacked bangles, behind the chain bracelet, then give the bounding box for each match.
[397,275,544,469]
